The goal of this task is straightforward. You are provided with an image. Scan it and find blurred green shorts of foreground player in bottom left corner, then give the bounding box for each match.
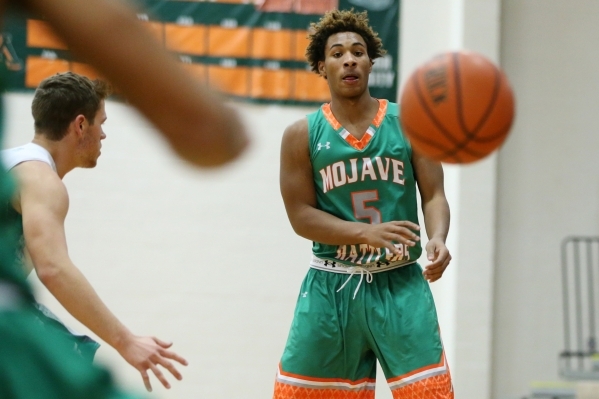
[0,304,139,399]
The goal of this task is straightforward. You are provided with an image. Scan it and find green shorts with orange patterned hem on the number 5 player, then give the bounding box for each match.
[274,263,454,399]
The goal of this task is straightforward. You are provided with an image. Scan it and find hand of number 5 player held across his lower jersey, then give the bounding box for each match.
[364,220,420,255]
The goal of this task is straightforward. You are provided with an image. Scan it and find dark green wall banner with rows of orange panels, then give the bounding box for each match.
[0,0,400,104]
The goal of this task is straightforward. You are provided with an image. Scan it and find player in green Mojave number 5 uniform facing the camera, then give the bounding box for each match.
[274,10,453,399]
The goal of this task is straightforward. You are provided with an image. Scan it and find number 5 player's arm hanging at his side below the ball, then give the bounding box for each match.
[412,151,451,282]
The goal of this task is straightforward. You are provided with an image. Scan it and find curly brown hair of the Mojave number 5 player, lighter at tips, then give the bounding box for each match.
[306,8,387,73]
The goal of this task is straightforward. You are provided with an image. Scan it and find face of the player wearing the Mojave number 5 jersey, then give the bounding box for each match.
[318,32,372,97]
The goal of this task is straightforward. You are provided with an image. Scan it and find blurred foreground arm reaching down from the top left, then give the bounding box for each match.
[20,0,248,166]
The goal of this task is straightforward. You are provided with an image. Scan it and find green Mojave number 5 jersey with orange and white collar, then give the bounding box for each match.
[307,100,422,266]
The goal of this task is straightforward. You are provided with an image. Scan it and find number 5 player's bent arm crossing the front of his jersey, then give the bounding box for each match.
[279,119,418,253]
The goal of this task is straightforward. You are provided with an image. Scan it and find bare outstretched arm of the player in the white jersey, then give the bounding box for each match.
[13,161,186,389]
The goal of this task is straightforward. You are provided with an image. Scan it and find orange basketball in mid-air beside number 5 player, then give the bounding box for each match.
[400,51,514,164]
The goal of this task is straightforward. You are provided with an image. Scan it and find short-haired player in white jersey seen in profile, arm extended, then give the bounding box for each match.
[2,72,187,389]
